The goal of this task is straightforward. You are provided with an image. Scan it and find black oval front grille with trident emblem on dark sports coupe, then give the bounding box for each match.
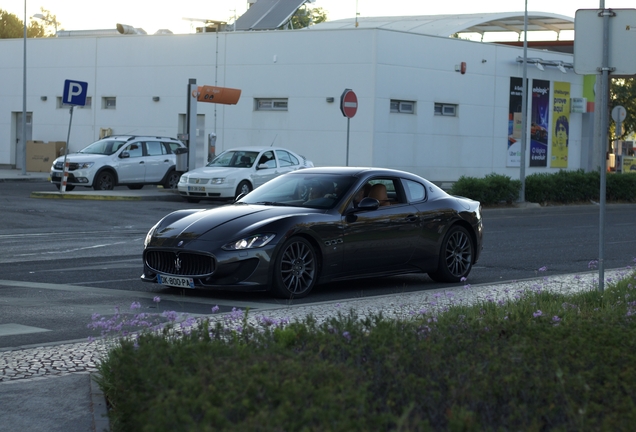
[145,250,214,276]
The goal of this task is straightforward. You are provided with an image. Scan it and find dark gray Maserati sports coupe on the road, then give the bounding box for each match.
[141,167,482,298]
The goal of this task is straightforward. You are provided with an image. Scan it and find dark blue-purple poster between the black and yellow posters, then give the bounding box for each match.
[530,80,550,167]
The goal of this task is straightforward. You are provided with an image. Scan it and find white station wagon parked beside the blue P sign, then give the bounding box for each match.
[51,135,187,191]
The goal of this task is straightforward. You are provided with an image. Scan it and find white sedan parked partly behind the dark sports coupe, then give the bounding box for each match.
[178,146,314,203]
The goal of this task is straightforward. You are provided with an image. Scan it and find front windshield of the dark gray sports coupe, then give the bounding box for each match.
[238,171,356,209]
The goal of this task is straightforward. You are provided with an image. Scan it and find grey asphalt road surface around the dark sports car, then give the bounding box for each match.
[0,182,636,349]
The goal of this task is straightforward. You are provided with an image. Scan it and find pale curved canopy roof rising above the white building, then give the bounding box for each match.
[313,12,574,39]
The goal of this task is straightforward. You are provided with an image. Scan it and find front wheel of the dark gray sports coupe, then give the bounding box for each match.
[272,237,318,299]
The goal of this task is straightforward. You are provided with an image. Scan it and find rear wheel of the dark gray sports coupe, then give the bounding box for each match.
[428,226,475,282]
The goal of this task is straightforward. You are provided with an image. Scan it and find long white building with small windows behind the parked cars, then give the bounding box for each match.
[0,13,591,182]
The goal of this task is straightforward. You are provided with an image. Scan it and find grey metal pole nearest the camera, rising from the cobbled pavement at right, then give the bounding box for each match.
[598,0,612,292]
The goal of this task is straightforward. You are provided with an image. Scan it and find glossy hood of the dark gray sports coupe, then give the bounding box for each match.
[153,204,321,246]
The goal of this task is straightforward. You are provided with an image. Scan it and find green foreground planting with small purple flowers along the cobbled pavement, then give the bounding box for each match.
[94,274,636,431]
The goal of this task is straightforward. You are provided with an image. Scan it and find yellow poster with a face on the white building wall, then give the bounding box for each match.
[550,82,570,168]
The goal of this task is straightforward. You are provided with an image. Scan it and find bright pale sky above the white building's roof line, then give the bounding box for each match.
[0,0,636,34]
